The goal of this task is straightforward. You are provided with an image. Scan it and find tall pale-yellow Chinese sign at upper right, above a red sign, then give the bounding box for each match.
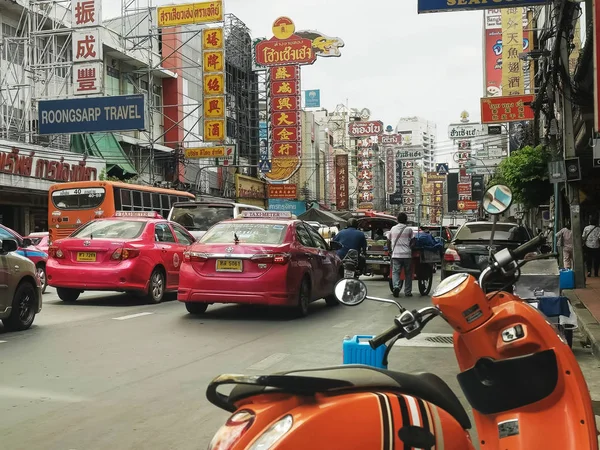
[500,8,525,96]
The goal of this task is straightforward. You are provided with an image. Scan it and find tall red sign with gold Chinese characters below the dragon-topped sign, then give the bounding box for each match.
[266,65,302,181]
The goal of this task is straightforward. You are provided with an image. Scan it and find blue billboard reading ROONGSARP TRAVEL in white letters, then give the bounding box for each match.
[38,94,146,134]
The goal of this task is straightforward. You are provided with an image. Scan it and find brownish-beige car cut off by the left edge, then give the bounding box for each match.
[0,238,42,331]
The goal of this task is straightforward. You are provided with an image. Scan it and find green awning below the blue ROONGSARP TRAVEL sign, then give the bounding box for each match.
[71,133,138,179]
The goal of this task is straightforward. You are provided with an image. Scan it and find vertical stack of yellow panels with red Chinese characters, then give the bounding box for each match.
[204,24,226,142]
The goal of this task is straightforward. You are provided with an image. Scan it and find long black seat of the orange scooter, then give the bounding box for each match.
[229,364,471,430]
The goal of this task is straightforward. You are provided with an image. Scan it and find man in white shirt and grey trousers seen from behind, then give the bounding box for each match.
[388,212,413,298]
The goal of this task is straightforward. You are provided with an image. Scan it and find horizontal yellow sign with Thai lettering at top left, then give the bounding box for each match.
[156,0,223,28]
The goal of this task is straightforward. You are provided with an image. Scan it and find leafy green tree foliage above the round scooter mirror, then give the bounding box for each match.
[490,145,552,209]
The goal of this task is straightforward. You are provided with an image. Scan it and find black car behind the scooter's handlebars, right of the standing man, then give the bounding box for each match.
[441,222,532,287]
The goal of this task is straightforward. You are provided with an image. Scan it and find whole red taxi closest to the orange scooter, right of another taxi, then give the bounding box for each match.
[177,211,343,316]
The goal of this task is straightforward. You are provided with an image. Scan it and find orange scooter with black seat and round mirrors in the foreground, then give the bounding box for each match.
[207,186,598,450]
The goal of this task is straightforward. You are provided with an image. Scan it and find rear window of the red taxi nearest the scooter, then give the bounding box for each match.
[200,222,288,245]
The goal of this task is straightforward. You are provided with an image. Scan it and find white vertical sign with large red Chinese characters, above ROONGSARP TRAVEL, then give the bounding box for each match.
[71,0,104,95]
